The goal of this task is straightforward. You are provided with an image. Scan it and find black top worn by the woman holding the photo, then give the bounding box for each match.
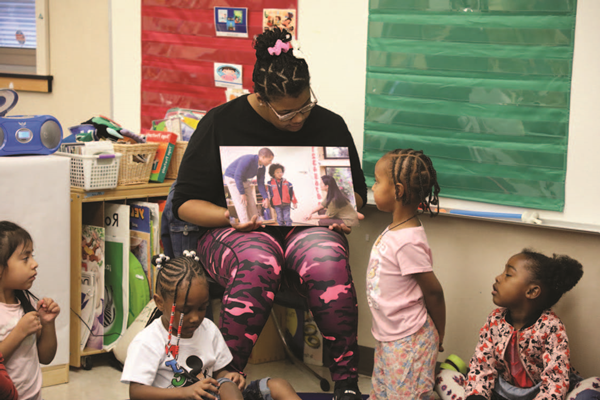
[173,96,367,228]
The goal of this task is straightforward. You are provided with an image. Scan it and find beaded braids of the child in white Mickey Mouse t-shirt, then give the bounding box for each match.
[152,250,207,360]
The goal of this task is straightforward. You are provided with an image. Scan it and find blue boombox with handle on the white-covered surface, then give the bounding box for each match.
[0,89,62,156]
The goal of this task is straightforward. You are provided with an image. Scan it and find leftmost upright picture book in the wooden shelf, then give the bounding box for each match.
[81,225,105,350]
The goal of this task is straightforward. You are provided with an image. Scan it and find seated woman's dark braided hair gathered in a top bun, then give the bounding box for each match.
[252,28,310,101]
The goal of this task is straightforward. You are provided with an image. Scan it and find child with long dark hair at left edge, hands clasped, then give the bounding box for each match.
[0,221,60,400]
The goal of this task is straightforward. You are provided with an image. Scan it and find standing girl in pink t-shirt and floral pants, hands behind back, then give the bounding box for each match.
[367,149,446,400]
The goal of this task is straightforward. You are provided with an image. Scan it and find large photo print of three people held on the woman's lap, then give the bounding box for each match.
[220,146,358,226]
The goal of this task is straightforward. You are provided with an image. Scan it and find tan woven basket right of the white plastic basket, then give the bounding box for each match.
[114,143,158,185]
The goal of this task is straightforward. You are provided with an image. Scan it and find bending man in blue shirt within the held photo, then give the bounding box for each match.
[223,147,274,224]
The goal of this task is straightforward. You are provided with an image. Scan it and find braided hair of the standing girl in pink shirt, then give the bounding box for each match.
[386,149,440,217]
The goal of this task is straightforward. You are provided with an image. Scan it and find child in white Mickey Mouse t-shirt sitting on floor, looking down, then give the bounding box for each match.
[121,250,300,400]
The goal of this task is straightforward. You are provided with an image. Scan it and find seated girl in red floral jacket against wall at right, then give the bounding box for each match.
[436,249,600,400]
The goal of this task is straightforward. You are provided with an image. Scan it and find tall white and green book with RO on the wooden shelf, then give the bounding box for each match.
[104,204,130,351]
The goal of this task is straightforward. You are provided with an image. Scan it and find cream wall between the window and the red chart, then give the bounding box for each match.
[9,0,112,132]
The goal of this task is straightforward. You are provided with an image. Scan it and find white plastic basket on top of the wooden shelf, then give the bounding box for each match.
[55,152,121,191]
